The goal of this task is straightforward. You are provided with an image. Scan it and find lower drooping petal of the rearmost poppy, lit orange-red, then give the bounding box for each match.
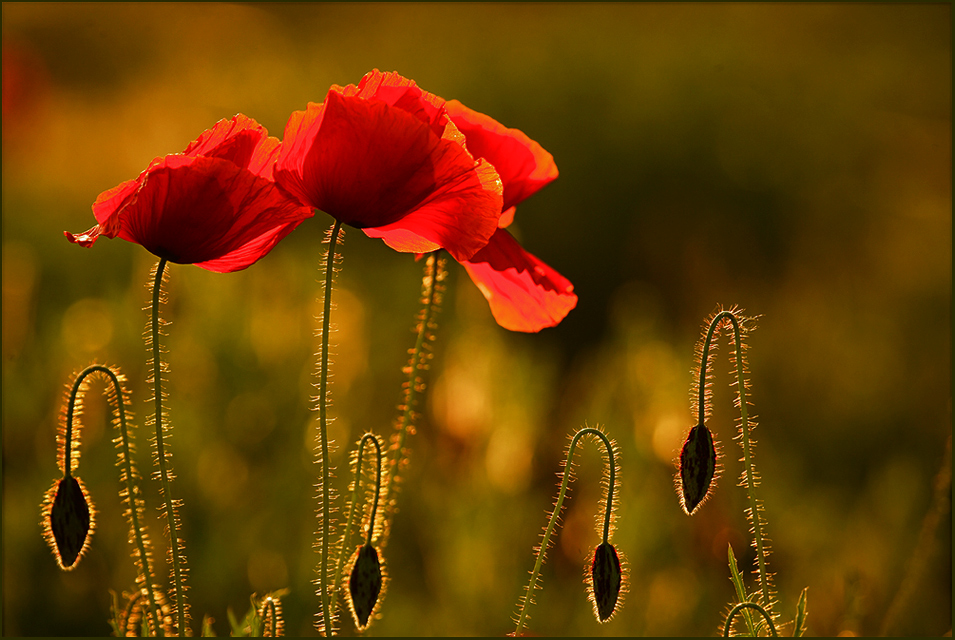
[461,229,577,333]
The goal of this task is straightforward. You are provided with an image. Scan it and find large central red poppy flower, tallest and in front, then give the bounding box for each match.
[275,69,502,260]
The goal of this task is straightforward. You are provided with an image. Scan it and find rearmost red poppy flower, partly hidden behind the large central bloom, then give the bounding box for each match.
[445,100,577,332]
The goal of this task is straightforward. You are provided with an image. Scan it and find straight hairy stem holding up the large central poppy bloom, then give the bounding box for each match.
[318,219,342,636]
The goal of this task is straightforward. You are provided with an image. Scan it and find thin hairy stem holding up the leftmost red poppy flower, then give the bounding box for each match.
[149,258,187,636]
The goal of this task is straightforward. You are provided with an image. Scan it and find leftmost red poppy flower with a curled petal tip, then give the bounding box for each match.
[64,114,314,272]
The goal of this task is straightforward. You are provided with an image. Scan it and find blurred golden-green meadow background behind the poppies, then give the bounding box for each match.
[3,3,952,636]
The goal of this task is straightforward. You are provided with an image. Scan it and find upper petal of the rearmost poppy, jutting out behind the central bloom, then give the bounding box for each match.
[445,100,557,212]
